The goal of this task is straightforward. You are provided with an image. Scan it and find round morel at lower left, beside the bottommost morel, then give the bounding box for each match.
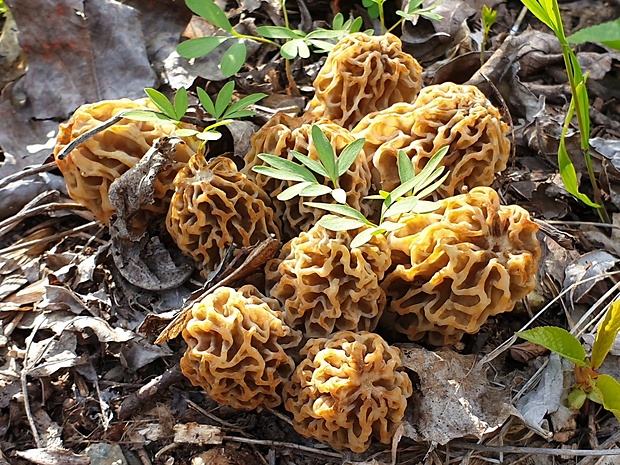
[181,285,301,410]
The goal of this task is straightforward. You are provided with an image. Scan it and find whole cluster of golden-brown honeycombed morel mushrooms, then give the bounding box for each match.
[55,33,541,452]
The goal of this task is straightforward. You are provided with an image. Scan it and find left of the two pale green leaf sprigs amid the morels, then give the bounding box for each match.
[252,125,365,204]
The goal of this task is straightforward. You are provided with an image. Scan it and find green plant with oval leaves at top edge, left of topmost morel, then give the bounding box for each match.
[177,0,362,78]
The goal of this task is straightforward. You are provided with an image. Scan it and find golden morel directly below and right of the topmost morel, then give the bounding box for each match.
[352,83,510,199]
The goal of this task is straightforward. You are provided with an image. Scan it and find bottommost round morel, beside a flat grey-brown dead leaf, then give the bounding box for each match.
[284,331,413,452]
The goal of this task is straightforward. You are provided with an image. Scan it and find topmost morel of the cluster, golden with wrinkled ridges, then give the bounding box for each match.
[307,32,422,129]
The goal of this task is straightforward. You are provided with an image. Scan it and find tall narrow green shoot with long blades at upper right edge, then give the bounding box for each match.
[521,0,609,223]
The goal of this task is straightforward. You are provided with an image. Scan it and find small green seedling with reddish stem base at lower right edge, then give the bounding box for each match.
[517,301,620,420]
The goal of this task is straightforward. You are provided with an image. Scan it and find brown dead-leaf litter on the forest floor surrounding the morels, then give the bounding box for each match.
[0,0,620,465]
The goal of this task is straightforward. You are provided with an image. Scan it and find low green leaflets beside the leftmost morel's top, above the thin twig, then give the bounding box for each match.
[123,81,267,143]
